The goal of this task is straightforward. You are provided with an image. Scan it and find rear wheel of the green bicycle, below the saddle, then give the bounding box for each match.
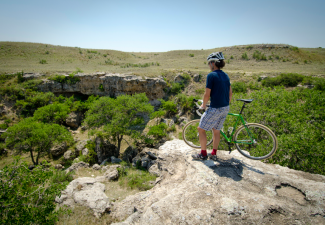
[234,123,278,160]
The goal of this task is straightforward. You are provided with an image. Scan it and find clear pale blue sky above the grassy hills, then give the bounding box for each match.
[0,0,325,52]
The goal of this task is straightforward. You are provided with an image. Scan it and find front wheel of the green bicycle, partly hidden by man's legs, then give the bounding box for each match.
[183,120,213,148]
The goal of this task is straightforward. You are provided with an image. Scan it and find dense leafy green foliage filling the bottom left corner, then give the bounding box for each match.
[0,158,72,224]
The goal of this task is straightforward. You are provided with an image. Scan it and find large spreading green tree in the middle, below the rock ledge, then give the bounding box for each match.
[84,93,153,151]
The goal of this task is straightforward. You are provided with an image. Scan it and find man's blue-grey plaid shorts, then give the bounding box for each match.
[199,105,229,131]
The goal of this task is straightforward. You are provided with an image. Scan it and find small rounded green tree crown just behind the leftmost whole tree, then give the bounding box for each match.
[34,103,70,124]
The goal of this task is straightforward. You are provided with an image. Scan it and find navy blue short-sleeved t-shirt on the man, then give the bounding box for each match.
[206,70,230,108]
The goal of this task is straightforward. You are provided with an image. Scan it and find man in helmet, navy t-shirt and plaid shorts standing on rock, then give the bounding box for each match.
[192,52,232,160]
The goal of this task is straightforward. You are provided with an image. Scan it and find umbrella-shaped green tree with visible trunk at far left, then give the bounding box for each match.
[2,118,73,165]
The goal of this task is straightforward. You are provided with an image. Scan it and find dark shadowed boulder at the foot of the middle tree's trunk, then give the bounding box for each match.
[95,137,119,163]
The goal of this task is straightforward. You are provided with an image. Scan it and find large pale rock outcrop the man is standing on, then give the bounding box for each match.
[111,140,325,224]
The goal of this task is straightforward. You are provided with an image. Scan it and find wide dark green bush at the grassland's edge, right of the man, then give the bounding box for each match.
[262,73,304,87]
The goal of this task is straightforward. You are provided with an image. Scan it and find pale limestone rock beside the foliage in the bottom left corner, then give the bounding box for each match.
[55,177,111,218]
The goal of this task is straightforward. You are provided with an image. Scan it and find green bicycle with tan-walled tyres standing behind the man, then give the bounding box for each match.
[183,99,278,160]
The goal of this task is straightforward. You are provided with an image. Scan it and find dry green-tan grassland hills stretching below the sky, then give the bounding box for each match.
[0,42,325,80]
